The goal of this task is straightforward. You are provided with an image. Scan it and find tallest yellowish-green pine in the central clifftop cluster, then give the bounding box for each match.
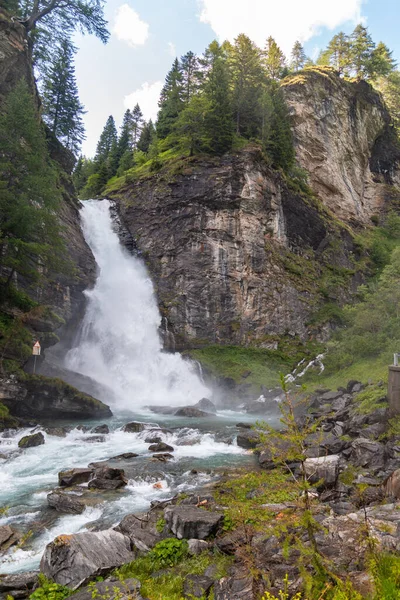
[229,34,263,138]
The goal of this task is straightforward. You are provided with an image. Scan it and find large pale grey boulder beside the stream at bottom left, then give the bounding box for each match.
[40,529,135,589]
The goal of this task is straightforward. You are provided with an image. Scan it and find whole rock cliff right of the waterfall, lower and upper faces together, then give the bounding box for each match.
[110,69,400,349]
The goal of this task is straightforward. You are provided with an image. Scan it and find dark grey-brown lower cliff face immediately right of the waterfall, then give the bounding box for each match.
[111,146,353,349]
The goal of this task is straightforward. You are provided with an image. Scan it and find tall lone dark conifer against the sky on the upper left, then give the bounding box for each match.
[41,40,85,154]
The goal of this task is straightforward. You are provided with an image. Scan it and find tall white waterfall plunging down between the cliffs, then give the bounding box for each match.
[65,200,209,410]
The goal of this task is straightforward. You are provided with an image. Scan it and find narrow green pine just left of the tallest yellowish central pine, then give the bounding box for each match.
[203,47,233,155]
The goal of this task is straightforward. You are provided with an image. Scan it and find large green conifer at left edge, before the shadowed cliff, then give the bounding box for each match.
[0,80,62,288]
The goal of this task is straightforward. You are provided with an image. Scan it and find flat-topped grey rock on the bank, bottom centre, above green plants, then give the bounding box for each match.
[164,506,224,540]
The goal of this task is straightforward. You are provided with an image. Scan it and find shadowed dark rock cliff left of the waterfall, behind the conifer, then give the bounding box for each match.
[0,10,95,366]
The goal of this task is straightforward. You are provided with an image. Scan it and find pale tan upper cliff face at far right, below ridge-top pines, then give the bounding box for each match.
[283,68,400,225]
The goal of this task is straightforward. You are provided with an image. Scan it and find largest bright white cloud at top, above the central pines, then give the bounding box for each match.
[199,0,364,53]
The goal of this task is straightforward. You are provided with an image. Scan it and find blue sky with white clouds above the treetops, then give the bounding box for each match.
[76,0,400,156]
